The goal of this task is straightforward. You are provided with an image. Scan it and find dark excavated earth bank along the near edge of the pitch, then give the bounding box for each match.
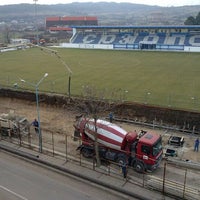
[0,89,200,133]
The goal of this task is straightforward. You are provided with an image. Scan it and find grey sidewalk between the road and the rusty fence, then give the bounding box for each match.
[0,140,172,200]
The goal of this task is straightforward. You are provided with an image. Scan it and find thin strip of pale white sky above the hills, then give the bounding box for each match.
[0,0,200,7]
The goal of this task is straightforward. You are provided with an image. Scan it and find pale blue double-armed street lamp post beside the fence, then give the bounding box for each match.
[20,73,48,153]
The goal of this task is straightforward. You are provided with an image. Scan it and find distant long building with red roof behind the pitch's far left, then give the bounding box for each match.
[45,16,98,32]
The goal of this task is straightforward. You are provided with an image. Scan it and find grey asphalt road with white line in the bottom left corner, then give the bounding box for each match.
[0,152,130,200]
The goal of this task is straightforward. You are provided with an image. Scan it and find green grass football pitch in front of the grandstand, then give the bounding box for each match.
[0,47,200,111]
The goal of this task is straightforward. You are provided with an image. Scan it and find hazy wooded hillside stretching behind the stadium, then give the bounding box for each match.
[0,2,200,25]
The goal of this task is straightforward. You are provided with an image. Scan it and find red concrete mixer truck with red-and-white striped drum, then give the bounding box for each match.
[74,117,163,172]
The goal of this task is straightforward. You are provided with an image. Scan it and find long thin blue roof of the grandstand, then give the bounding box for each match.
[72,25,200,29]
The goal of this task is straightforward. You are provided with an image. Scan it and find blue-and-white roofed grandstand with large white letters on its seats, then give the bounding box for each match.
[67,25,200,51]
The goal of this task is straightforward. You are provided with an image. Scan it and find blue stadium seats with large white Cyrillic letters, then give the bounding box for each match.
[72,32,200,50]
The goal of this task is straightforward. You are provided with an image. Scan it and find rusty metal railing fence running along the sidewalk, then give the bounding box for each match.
[0,128,200,200]
